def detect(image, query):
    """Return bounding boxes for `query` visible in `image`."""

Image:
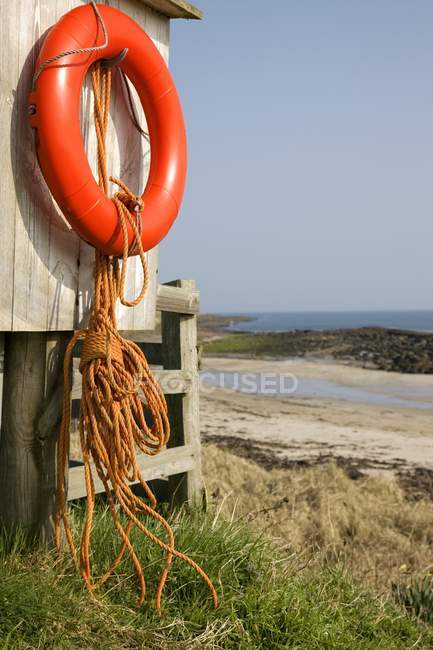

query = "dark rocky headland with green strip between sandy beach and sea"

[201,317,433,374]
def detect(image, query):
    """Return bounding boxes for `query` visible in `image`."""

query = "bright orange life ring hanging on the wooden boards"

[29,5,186,255]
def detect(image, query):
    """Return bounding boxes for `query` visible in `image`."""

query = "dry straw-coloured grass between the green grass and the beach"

[203,444,433,592]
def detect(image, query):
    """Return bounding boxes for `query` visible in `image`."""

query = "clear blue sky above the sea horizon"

[160,0,433,312]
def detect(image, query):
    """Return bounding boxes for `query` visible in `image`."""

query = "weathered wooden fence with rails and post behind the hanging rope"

[68,280,202,502]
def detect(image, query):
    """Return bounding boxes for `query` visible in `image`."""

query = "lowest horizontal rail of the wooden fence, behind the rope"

[68,447,196,500]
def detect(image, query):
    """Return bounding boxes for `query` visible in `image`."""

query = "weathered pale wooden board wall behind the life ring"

[0,0,169,331]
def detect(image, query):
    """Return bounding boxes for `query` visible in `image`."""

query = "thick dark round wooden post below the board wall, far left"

[0,332,71,544]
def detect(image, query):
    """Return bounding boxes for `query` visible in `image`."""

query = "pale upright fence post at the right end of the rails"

[161,280,203,505]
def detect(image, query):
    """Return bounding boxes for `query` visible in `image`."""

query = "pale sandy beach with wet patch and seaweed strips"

[201,356,433,474]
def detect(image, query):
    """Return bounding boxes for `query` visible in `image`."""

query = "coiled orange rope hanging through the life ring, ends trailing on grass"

[56,64,218,609]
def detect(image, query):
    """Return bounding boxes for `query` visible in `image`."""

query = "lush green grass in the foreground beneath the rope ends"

[0,506,433,650]
